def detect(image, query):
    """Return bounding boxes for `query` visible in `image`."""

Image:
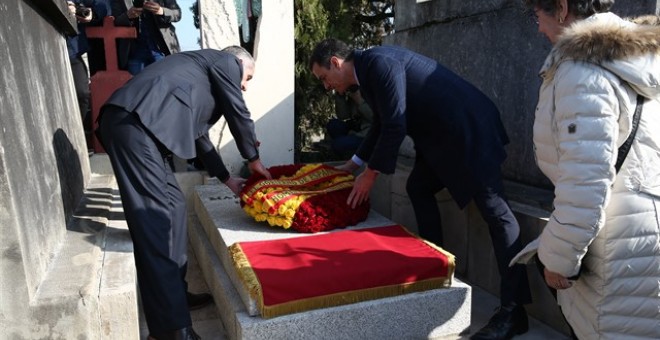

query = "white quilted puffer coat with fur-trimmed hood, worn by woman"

[514,13,660,339]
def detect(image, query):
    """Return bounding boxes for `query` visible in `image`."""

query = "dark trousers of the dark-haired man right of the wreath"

[406,156,532,306]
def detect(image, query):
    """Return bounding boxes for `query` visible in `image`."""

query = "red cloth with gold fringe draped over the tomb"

[239,225,454,306]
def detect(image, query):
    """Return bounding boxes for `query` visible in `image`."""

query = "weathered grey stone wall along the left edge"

[0,0,90,339]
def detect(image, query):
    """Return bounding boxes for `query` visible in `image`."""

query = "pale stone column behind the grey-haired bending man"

[200,0,295,175]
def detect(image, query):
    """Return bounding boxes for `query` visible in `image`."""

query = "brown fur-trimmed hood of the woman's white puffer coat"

[541,13,660,98]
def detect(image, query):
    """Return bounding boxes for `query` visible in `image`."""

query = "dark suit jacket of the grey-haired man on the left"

[104,49,259,180]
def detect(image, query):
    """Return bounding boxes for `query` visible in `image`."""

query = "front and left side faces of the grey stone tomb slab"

[189,211,472,340]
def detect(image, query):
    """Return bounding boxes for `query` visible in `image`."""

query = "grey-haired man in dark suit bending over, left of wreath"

[99,46,271,340]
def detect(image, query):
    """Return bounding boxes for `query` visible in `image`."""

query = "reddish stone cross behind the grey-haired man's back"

[85,16,137,153]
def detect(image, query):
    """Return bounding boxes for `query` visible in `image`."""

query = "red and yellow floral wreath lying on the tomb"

[241,164,370,233]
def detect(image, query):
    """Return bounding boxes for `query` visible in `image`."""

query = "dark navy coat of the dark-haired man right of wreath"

[354,46,508,207]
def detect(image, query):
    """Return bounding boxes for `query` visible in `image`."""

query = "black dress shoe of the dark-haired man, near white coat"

[470,306,529,340]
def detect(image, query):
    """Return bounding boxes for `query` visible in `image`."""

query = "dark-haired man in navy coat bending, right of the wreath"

[310,39,531,339]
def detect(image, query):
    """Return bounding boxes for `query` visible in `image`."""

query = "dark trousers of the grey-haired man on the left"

[99,106,192,334]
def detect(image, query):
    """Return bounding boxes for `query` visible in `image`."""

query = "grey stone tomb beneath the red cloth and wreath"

[189,185,471,340]
